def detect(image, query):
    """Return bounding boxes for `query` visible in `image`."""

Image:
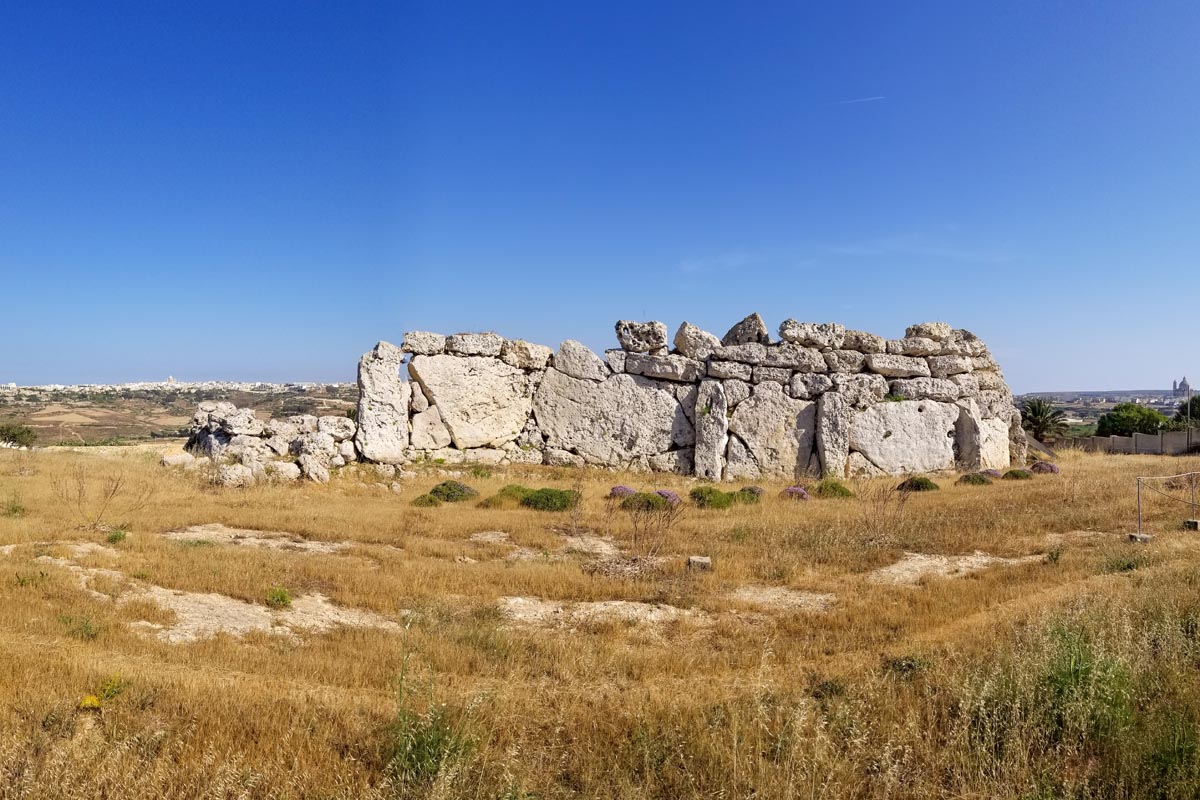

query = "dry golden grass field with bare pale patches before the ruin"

[0,447,1200,799]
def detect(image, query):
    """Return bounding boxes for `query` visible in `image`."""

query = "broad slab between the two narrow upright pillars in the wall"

[730,383,816,477]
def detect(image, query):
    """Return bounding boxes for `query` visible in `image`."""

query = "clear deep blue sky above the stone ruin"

[0,0,1200,392]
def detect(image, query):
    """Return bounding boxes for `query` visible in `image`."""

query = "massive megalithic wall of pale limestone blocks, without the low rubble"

[354,314,1025,480]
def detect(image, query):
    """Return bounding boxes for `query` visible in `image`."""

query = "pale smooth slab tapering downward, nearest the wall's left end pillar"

[408,355,530,450]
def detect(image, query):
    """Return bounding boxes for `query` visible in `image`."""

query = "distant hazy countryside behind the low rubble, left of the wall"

[0,386,358,445]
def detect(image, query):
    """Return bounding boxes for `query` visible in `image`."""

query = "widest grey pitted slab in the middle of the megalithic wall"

[533,368,696,467]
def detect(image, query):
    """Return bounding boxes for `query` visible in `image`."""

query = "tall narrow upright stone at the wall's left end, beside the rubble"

[354,342,413,464]
